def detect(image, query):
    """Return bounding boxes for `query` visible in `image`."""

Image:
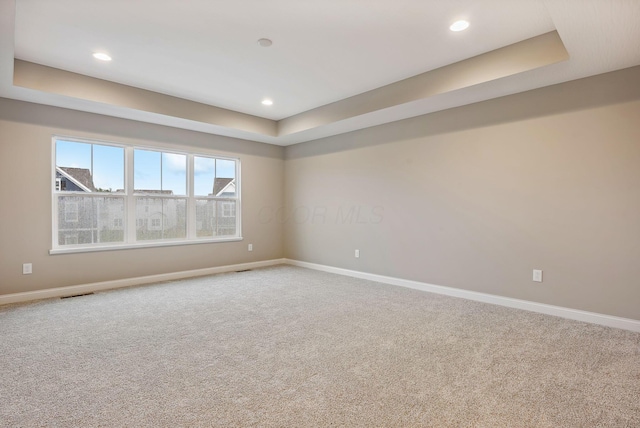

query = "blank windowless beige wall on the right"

[284,67,640,319]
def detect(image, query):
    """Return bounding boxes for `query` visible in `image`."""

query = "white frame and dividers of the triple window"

[49,135,243,254]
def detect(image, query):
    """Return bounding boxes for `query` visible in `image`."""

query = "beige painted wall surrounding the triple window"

[0,99,283,294]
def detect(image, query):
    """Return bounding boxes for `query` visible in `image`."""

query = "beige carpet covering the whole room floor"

[0,266,640,427]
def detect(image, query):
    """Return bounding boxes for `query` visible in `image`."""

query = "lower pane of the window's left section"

[58,196,124,245]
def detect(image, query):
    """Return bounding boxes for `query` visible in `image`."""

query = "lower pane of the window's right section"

[196,199,236,238]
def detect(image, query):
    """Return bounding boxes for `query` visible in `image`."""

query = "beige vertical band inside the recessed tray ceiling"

[13,31,569,144]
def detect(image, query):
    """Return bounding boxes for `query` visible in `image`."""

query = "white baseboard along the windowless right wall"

[285,259,640,332]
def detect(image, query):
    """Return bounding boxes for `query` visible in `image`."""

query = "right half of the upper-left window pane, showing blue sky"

[93,144,124,192]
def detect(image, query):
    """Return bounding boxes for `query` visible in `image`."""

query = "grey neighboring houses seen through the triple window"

[55,167,236,245]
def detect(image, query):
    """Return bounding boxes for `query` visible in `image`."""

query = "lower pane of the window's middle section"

[136,197,187,241]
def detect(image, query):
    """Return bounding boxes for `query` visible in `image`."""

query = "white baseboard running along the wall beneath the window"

[0,259,286,305]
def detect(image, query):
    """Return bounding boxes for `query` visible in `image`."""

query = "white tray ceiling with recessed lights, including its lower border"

[0,0,640,145]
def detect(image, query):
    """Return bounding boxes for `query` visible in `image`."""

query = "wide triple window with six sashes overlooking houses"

[52,137,241,252]
